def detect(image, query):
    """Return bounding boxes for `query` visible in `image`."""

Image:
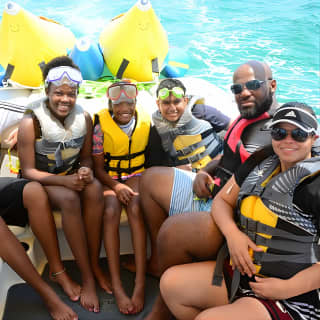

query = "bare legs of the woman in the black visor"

[160,261,271,320]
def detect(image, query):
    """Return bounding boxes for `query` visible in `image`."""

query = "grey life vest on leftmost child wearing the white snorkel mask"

[26,98,87,174]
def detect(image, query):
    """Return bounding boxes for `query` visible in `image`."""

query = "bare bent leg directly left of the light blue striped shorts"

[140,167,174,276]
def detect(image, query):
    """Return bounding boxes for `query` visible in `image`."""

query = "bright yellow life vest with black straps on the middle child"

[95,106,151,180]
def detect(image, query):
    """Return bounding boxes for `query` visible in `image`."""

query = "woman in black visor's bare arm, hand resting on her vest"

[211,176,262,277]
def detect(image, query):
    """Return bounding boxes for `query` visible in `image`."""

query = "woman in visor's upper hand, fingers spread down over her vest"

[226,230,263,277]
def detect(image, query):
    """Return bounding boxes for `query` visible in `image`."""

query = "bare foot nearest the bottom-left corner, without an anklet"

[44,293,78,320]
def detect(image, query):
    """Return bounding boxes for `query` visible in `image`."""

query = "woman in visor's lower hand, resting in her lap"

[249,276,292,300]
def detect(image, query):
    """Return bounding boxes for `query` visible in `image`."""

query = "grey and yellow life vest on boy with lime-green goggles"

[152,97,223,169]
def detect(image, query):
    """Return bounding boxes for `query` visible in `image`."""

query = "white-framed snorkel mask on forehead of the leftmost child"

[44,66,82,88]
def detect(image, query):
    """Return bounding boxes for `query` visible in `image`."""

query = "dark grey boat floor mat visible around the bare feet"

[3,258,159,320]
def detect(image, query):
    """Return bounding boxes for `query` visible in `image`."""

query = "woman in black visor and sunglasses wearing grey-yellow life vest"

[160,102,320,320]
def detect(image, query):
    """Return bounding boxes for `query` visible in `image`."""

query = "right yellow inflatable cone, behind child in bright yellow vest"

[99,0,169,81]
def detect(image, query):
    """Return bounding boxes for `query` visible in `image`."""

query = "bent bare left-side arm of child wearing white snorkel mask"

[18,115,84,191]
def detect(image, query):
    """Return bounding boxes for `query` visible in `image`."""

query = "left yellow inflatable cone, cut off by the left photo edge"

[0,2,76,88]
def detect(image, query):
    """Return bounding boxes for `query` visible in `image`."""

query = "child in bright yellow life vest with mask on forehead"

[93,81,151,314]
